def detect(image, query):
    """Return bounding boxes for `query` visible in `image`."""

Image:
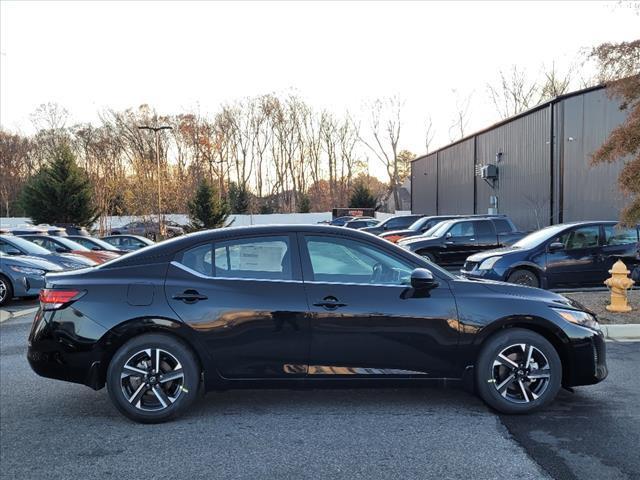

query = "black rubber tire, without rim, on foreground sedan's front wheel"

[475,328,562,414]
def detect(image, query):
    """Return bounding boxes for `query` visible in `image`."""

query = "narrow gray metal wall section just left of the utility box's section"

[438,138,475,214]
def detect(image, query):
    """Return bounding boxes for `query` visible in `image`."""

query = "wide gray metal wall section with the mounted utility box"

[475,107,551,230]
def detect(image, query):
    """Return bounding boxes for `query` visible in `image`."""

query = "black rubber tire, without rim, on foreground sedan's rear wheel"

[106,333,200,423]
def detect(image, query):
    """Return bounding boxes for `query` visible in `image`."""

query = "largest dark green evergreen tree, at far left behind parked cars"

[20,144,99,227]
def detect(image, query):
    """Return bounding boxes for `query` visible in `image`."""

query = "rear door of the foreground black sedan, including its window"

[165,235,310,378]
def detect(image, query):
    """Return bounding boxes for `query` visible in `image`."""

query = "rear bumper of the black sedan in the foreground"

[27,307,106,390]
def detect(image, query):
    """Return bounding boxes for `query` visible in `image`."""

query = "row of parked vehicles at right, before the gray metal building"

[362,215,640,289]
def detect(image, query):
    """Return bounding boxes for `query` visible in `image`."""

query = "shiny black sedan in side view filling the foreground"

[27,225,607,422]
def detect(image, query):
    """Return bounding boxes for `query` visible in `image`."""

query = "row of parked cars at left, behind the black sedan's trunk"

[0,232,154,305]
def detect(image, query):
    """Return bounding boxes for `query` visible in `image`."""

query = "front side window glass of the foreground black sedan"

[305,236,413,285]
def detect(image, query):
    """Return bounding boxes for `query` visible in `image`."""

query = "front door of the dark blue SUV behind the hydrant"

[547,225,600,287]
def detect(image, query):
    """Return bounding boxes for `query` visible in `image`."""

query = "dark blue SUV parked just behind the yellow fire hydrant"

[462,222,640,288]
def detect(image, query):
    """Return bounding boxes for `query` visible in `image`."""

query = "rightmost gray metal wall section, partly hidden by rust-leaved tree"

[557,90,627,222]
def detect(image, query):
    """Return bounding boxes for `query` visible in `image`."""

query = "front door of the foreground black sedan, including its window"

[300,234,459,378]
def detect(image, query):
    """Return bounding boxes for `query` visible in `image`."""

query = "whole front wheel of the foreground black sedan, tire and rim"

[475,328,562,414]
